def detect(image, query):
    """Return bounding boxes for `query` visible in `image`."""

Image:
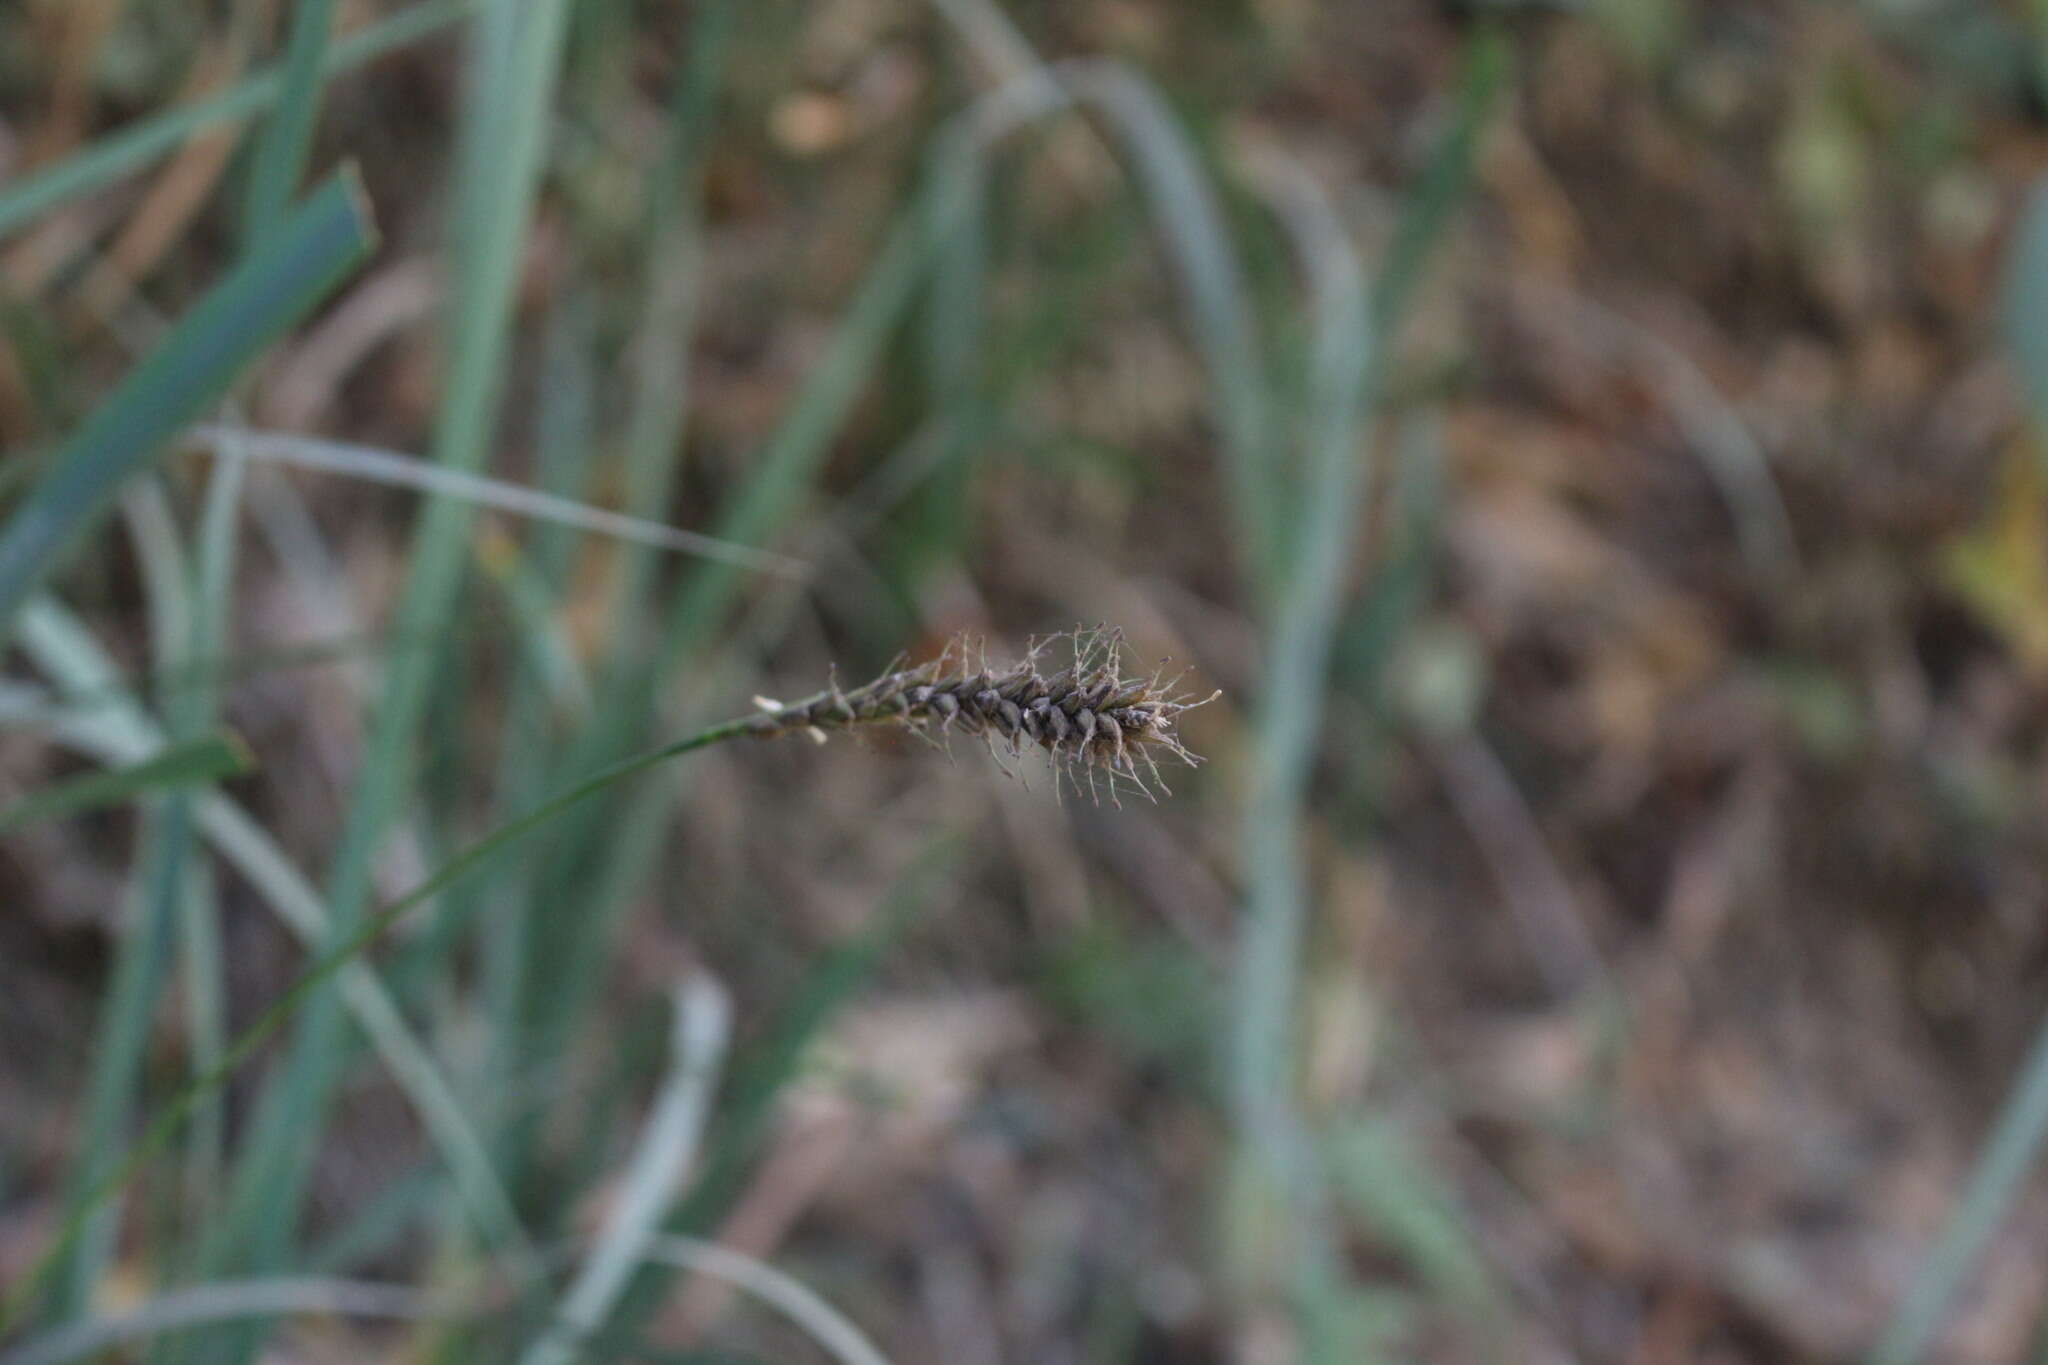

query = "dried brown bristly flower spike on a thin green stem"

[748,628,1221,800]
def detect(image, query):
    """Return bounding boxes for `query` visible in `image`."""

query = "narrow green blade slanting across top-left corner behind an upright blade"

[0,0,471,237]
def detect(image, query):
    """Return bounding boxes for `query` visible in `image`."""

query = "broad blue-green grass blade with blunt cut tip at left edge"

[0,170,375,643]
